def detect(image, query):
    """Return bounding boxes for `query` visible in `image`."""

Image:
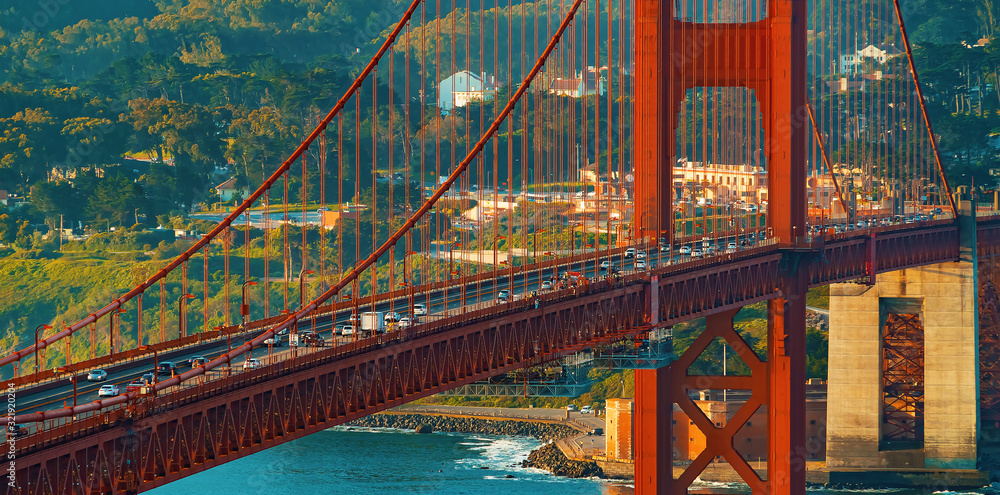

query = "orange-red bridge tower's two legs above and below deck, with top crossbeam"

[633,0,808,494]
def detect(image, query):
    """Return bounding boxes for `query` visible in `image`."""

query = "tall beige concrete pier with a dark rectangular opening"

[827,202,981,485]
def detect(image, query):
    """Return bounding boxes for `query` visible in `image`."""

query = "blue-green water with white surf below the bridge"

[147,426,1000,495]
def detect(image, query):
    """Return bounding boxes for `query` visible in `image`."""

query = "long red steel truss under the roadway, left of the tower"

[8,284,648,494]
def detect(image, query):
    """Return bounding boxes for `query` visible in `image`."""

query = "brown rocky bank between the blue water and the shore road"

[344,413,605,478]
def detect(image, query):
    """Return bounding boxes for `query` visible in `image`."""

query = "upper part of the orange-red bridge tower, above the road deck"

[633,0,808,243]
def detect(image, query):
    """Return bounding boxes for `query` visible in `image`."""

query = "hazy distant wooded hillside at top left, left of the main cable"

[0,0,406,85]
